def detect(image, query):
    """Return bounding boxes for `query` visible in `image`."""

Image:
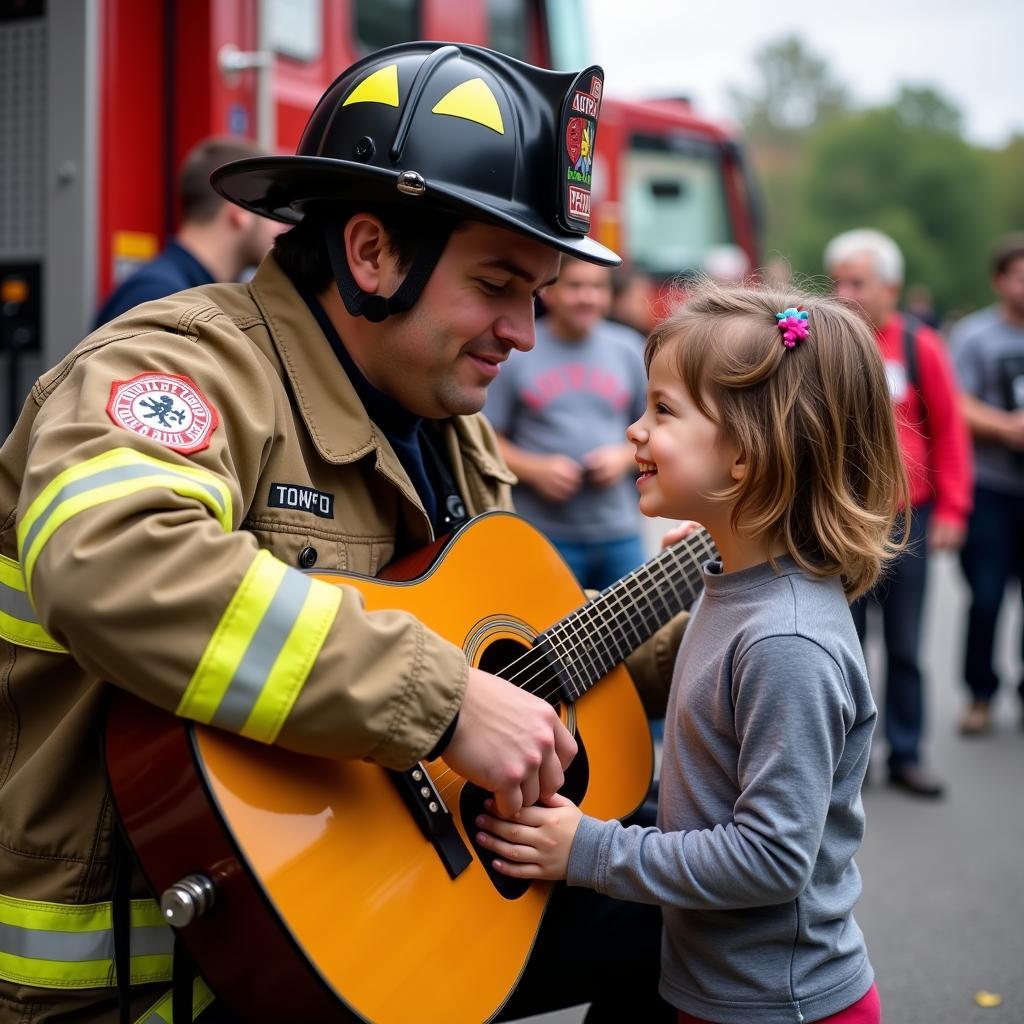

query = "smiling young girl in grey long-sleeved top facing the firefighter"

[477,285,906,1024]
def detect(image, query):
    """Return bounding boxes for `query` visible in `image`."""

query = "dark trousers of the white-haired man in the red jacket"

[850,505,932,769]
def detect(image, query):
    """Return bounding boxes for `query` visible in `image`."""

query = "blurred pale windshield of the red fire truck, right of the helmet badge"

[625,137,733,276]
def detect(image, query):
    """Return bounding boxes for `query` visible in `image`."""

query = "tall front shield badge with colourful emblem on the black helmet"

[558,68,604,234]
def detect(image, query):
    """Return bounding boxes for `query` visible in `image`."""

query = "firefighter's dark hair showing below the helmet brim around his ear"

[273,203,461,294]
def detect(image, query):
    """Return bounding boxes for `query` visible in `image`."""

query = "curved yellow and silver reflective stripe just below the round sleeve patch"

[17,449,231,593]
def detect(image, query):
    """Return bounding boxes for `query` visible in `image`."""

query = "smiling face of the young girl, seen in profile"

[627,344,742,527]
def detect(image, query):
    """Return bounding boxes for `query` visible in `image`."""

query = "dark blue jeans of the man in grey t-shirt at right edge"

[961,487,1024,700]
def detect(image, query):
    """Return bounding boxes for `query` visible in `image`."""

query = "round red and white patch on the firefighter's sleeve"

[106,373,220,455]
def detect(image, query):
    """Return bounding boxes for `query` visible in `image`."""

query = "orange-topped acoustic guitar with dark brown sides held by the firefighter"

[106,512,715,1024]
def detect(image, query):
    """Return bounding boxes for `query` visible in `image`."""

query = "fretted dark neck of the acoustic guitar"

[537,529,718,696]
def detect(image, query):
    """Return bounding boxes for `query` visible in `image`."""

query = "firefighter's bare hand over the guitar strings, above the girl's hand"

[443,669,577,817]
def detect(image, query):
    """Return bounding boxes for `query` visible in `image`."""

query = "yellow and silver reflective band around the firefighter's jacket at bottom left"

[0,894,174,988]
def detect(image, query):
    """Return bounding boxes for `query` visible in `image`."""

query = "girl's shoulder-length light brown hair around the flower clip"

[645,282,908,599]
